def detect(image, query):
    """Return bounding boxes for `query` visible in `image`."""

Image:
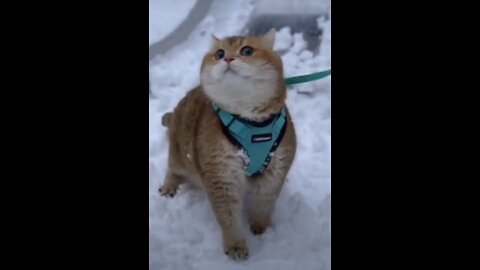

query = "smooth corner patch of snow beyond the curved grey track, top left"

[148,0,197,45]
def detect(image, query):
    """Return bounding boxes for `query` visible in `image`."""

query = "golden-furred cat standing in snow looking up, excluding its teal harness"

[159,29,296,259]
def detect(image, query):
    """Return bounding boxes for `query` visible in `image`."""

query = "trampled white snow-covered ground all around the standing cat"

[149,0,331,270]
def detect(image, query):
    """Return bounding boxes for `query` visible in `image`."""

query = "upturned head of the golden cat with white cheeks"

[201,29,286,119]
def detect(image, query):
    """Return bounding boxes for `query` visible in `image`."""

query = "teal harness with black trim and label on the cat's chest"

[214,106,287,176]
